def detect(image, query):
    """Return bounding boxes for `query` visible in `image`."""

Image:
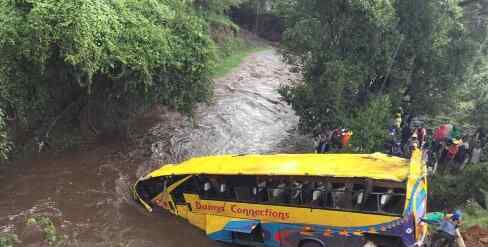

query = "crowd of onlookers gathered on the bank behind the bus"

[315,109,487,175]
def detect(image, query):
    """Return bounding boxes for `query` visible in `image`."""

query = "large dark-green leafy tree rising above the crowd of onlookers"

[277,0,474,151]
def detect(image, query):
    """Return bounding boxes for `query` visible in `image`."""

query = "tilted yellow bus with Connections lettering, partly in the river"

[133,150,427,247]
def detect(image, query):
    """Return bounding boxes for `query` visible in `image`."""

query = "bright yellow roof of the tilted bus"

[148,153,410,182]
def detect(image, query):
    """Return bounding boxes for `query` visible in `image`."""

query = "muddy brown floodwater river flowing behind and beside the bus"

[0,50,309,247]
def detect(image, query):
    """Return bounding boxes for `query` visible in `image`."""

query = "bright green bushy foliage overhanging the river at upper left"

[0,0,217,158]
